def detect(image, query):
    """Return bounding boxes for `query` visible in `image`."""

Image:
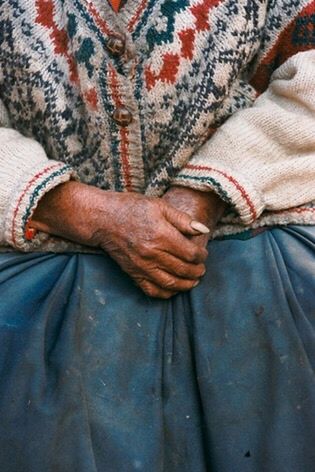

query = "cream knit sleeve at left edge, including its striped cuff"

[0,101,72,250]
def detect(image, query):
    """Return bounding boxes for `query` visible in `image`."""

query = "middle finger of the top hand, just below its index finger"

[154,252,206,279]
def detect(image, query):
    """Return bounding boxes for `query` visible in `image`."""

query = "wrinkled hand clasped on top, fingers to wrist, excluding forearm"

[92,192,207,298]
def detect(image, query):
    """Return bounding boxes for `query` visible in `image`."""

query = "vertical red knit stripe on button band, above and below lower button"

[109,66,132,192]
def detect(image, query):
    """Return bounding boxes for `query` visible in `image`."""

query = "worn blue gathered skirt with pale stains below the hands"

[0,226,315,472]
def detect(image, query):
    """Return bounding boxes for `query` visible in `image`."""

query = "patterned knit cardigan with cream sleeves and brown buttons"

[0,0,315,251]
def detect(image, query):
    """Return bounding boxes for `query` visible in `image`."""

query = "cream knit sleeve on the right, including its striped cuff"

[173,50,315,225]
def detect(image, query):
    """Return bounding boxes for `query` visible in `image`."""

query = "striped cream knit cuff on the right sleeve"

[172,159,264,225]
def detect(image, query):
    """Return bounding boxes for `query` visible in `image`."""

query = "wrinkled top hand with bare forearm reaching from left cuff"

[32,181,207,298]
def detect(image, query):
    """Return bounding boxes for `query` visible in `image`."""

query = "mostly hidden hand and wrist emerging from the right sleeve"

[163,186,226,247]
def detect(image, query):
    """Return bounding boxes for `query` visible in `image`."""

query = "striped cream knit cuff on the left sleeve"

[4,160,74,251]
